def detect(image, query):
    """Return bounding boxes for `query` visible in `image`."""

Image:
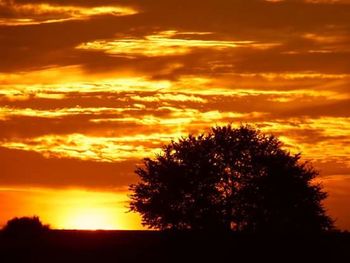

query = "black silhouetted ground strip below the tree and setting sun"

[0,230,350,263]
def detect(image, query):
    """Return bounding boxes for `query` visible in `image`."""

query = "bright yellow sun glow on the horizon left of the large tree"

[0,187,142,230]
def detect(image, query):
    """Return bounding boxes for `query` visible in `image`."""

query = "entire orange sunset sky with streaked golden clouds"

[0,0,350,230]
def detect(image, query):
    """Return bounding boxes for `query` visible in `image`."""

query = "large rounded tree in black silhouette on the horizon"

[130,125,333,233]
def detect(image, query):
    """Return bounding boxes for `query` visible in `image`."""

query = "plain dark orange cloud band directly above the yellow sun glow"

[0,147,137,188]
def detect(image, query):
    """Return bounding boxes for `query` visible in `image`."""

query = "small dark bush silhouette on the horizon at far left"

[3,216,49,236]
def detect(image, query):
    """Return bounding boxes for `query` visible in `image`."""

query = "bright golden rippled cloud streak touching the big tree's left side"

[1,134,161,162]
